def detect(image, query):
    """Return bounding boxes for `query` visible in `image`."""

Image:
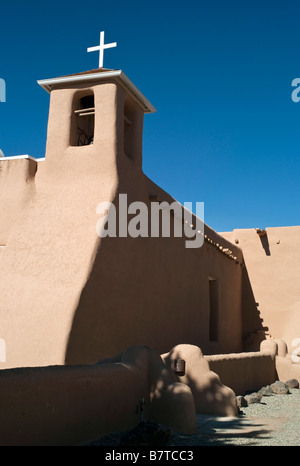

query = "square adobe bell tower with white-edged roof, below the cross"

[38,68,155,168]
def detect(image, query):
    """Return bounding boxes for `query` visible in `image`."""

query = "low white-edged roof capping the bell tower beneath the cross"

[38,68,156,113]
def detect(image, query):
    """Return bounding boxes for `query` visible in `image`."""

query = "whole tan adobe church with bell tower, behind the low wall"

[0,35,300,444]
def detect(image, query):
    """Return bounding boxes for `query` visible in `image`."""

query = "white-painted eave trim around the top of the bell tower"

[37,70,156,113]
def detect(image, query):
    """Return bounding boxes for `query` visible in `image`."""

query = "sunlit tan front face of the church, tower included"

[0,84,118,368]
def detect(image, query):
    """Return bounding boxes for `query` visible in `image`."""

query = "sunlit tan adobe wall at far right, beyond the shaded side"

[222,226,300,352]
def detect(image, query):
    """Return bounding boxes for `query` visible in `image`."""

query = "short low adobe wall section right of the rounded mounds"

[205,340,278,395]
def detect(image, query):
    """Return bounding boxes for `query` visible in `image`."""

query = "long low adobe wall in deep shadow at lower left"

[0,365,147,446]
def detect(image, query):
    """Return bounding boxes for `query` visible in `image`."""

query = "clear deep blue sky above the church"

[0,0,300,231]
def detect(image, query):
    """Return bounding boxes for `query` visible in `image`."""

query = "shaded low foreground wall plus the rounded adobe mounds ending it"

[0,345,237,446]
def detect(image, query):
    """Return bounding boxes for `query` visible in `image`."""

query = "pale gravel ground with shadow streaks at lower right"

[170,389,300,446]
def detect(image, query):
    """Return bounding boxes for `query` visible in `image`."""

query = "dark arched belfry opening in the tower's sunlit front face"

[71,93,95,146]
